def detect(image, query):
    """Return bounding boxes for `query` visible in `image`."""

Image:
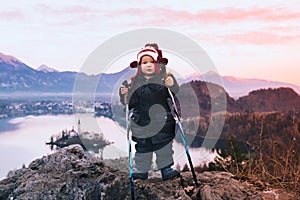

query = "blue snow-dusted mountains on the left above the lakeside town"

[0,53,118,93]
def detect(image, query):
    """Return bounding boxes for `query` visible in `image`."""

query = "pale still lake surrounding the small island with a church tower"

[0,114,217,179]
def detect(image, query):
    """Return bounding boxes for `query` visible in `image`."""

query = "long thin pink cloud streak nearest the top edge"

[115,7,300,24]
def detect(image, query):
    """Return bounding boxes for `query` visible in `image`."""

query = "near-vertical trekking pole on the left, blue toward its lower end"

[122,80,134,200]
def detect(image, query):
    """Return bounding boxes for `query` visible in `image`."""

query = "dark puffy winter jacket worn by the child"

[120,74,179,144]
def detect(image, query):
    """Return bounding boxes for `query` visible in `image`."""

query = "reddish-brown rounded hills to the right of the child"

[176,81,300,115]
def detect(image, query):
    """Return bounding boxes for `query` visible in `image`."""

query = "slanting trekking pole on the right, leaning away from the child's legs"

[168,88,199,187]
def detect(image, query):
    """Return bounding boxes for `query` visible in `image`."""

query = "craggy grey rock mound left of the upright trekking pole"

[0,146,127,199]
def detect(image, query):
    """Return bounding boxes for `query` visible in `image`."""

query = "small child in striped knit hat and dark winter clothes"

[120,44,180,180]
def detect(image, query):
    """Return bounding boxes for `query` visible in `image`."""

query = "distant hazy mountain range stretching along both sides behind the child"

[0,53,300,99]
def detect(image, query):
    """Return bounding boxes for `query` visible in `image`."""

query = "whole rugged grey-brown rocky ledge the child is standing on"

[0,146,296,200]
